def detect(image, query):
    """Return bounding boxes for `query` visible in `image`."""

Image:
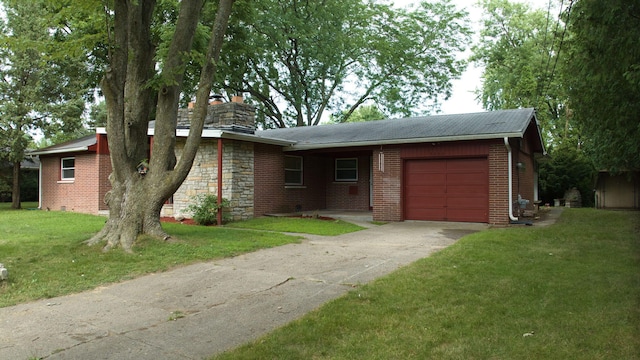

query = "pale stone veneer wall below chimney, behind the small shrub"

[162,139,254,221]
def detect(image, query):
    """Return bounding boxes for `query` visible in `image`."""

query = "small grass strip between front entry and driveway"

[226,217,364,236]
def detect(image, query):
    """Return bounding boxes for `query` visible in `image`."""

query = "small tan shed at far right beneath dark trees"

[595,170,640,209]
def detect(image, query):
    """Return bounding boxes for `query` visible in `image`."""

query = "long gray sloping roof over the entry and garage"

[256,108,542,150]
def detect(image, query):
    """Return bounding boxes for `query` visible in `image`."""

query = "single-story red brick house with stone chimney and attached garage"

[31,101,545,226]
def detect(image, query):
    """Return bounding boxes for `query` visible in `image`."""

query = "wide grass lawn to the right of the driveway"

[215,209,640,360]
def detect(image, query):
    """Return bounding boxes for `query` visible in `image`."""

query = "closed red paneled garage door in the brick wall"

[404,158,489,222]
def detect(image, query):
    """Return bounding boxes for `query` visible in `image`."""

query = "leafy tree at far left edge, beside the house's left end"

[0,0,87,209]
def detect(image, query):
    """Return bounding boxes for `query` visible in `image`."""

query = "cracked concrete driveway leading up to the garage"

[0,221,487,360]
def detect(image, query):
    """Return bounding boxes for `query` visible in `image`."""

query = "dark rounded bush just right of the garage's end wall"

[539,145,596,206]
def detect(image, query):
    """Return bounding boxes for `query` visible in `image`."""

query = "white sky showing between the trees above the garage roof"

[392,0,557,114]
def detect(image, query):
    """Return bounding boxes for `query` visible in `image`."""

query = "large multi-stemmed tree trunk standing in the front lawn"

[87,0,234,251]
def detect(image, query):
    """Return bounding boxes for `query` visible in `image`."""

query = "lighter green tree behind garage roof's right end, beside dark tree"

[472,0,579,147]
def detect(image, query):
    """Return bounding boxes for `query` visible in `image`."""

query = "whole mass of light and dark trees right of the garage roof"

[471,0,640,205]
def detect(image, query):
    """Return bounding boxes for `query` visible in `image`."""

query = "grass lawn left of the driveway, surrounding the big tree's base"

[0,208,310,307]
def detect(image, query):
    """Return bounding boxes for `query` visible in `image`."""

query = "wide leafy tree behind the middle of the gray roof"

[212,0,469,127]
